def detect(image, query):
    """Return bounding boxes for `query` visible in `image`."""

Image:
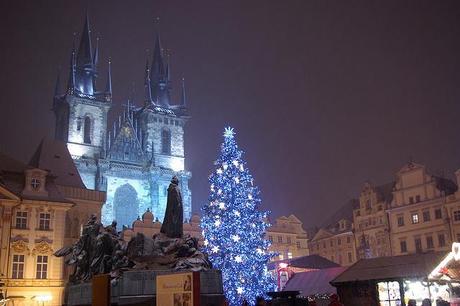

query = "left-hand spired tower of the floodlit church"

[53,15,112,189]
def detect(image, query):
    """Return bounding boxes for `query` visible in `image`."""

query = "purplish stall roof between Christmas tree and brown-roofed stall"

[283,267,346,296]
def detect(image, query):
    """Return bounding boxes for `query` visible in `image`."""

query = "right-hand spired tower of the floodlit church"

[136,34,191,219]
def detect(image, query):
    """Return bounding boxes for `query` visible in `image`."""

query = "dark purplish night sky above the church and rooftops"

[0,0,460,226]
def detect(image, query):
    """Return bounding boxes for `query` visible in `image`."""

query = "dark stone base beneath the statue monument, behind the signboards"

[64,270,224,306]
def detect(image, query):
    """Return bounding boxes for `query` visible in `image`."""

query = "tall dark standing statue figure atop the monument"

[160,176,184,238]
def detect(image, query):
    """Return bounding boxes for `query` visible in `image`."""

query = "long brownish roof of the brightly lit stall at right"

[331,252,447,285]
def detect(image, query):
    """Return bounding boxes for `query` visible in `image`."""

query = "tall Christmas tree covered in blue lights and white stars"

[201,127,276,306]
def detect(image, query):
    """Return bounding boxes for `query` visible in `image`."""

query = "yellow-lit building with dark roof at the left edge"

[0,142,105,306]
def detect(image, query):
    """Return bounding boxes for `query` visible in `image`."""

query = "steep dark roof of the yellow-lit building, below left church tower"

[29,138,86,188]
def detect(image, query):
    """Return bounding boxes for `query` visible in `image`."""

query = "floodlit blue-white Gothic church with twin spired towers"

[53,16,191,229]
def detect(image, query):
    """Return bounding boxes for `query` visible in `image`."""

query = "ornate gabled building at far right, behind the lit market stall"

[387,162,457,255]
